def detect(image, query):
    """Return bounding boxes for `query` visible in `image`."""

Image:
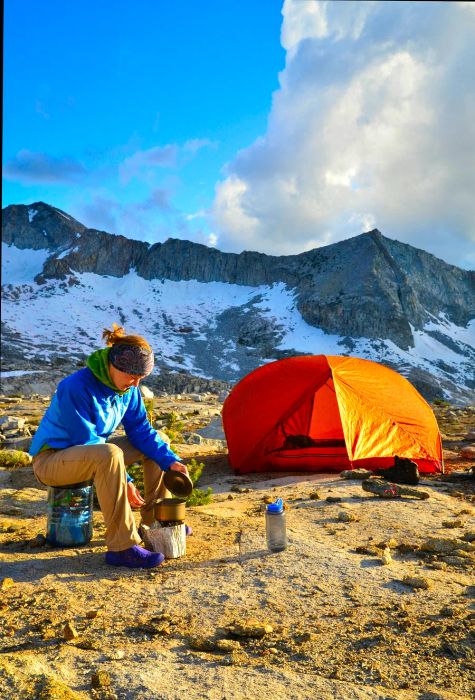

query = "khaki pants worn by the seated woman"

[33,436,171,552]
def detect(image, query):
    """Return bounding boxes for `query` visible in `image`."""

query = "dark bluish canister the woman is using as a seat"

[46,481,94,547]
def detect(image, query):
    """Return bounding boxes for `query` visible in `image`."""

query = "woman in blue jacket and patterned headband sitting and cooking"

[30,324,188,569]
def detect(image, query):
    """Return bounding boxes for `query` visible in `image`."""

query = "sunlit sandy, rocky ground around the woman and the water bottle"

[0,396,475,700]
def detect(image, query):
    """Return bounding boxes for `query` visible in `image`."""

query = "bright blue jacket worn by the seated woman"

[30,367,179,471]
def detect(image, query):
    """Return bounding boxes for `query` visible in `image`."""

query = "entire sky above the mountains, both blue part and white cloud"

[3,0,475,269]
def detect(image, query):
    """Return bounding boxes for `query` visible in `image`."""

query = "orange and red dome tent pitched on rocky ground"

[223,355,443,474]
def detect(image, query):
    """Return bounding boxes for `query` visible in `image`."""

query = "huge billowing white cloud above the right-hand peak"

[213,0,475,266]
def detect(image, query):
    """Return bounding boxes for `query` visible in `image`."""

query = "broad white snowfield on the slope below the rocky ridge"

[3,260,475,396]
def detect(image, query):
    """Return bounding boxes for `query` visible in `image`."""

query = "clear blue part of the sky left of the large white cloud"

[3,0,284,242]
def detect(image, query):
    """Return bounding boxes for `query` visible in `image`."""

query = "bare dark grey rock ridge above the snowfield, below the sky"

[2,202,475,356]
